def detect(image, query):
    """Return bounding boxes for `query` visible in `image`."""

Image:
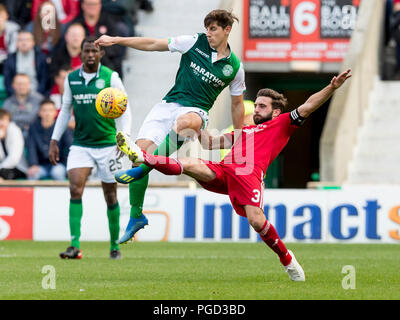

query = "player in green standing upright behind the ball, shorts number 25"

[49,37,131,259]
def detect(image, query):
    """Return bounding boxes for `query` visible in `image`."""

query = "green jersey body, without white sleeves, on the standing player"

[68,65,116,148]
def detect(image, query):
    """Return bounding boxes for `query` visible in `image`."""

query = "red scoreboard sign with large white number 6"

[243,0,360,62]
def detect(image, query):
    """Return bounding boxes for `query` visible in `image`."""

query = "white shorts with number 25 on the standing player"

[67,145,128,183]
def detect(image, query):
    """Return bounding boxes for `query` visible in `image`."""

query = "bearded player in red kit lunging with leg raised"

[117,69,351,281]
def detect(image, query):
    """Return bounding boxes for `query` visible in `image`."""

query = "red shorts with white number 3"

[197,160,264,217]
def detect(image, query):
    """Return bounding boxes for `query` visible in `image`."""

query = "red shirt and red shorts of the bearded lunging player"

[198,110,301,217]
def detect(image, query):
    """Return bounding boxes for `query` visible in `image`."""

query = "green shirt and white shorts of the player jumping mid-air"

[136,33,246,145]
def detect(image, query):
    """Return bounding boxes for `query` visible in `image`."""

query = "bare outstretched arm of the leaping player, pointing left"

[95,35,168,51]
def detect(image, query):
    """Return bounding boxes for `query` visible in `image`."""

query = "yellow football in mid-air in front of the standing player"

[96,88,128,119]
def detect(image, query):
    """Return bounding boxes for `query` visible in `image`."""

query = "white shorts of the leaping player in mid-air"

[136,101,208,146]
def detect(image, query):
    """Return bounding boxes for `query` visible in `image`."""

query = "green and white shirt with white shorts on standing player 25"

[52,65,131,183]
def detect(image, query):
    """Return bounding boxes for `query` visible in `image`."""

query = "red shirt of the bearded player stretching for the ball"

[222,113,299,175]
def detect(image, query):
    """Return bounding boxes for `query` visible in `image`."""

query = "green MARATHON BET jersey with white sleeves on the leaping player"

[164,33,245,112]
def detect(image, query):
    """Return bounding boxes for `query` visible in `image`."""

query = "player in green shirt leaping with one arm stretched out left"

[96,10,245,243]
